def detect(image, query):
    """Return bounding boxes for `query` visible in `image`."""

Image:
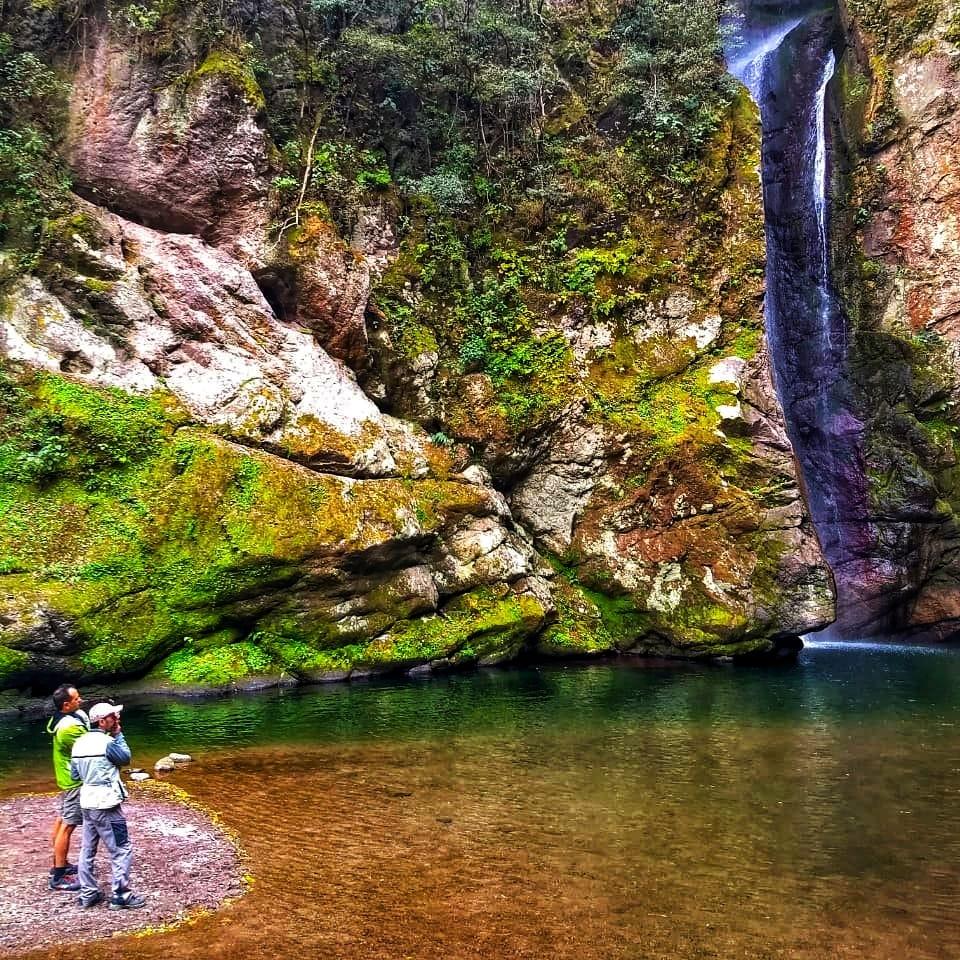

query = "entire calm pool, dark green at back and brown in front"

[0,645,960,960]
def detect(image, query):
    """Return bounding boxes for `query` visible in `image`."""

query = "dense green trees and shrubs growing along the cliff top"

[0,0,731,244]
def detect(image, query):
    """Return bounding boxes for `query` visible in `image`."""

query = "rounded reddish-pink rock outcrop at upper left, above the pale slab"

[67,28,272,262]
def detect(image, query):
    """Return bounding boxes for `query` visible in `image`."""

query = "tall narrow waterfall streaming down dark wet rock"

[725,0,875,632]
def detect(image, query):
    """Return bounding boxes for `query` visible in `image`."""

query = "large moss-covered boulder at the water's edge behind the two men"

[0,372,553,687]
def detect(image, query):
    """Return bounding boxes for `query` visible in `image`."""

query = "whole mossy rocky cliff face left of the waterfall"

[0,4,833,687]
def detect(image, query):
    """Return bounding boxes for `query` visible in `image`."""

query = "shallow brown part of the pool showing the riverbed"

[1,727,960,960]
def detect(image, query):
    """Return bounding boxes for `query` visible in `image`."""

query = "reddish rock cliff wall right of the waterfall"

[835,0,960,639]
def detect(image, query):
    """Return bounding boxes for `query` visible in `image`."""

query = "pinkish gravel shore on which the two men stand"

[0,781,244,953]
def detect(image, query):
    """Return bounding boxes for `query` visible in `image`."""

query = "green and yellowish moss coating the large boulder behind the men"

[0,364,527,682]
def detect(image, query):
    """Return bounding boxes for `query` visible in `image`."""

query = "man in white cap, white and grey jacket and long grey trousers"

[70,703,146,910]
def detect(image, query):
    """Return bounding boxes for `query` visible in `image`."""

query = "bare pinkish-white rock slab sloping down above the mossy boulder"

[0,205,398,476]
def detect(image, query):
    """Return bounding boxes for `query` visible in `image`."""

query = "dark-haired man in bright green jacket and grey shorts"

[47,684,90,893]
